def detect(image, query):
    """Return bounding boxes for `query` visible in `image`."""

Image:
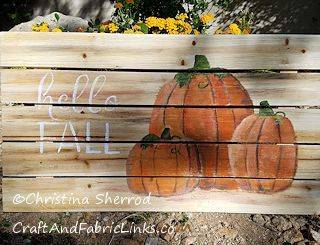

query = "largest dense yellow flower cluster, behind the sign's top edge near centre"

[145,13,193,34]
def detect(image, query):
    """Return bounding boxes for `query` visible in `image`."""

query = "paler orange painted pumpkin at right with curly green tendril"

[229,101,297,193]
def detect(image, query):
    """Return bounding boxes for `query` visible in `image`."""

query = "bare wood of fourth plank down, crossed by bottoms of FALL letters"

[2,142,320,179]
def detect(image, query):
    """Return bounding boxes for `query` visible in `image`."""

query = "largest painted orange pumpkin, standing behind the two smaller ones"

[149,55,253,189]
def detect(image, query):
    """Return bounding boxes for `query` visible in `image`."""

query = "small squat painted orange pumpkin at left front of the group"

[127,129,200,197]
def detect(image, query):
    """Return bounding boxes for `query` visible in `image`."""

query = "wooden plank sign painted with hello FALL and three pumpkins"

[0,33,320,214]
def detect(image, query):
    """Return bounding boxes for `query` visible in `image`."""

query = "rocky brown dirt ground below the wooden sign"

[0,206,320,245]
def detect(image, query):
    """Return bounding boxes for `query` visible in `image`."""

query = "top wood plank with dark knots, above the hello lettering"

[0,32,320,70]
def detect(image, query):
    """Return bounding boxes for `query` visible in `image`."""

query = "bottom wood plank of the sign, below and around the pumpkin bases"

[3,178,320,214]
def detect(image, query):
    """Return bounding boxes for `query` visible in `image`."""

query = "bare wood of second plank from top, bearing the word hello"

[1,69,320,106]
